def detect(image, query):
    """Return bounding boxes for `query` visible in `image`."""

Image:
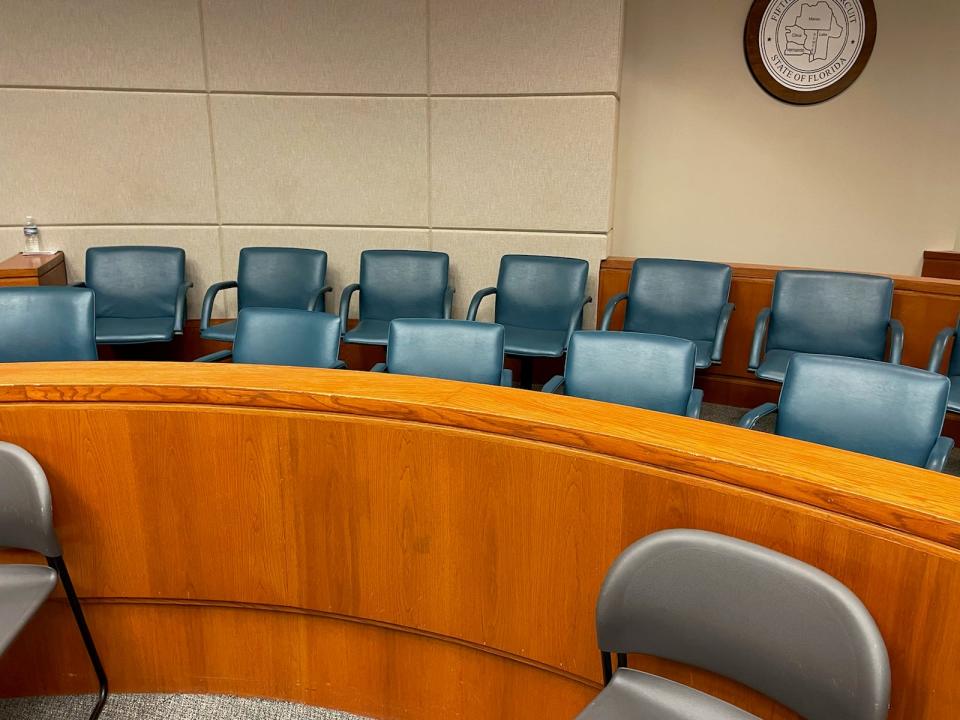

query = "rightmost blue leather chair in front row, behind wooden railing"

[739,355,953,471]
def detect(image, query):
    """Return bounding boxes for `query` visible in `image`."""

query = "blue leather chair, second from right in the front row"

[543,331,703,418]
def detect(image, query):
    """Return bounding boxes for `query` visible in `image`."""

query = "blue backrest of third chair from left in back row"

[360,250,450,320]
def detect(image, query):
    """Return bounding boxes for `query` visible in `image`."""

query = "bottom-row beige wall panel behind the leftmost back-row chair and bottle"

[0,225,222,318]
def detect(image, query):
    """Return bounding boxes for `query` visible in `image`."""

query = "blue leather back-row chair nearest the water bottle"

[79,245,193,345]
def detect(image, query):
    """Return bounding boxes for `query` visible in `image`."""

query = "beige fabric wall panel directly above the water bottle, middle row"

[0,90,216,225]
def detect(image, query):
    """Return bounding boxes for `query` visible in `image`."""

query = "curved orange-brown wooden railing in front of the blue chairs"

[0,363,960,720]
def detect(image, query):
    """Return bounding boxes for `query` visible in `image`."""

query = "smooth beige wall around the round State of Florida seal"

[611,0,960,274]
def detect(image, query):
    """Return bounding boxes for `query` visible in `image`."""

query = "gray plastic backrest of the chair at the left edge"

[0,442,61,557]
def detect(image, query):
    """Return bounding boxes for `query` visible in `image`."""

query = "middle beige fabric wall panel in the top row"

[203,0,427,95]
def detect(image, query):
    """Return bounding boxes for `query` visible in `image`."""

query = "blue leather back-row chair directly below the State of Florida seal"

[748,270,903,382]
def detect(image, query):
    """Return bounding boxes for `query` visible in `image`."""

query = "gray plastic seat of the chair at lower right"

[577,668,757,720]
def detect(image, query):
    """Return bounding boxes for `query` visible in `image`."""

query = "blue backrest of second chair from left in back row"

[237,247,327,310]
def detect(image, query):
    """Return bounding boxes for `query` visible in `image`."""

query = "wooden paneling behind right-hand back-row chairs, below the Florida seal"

[597,258,960,416]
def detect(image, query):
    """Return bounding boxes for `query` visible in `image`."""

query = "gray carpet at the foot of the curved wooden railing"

[0,694,372,720]
